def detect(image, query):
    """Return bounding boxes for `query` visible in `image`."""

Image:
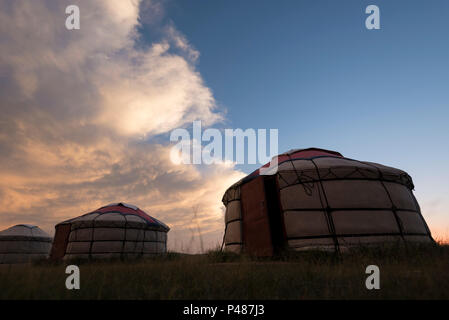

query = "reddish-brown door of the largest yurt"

[242,176,273,256]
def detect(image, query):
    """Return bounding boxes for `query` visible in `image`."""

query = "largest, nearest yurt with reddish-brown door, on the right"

[222,148,433,256]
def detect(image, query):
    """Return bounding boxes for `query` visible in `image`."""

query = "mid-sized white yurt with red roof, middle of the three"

[51,203,170,260]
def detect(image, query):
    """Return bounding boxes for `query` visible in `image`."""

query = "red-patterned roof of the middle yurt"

[58,202,170,232]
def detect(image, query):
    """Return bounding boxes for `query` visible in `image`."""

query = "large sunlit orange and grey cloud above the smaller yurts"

[0,0,242,250]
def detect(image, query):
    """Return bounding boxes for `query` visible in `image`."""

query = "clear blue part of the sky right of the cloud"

[142,0,449,235]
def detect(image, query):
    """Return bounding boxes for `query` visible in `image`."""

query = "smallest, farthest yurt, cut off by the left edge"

[0,224,52,264]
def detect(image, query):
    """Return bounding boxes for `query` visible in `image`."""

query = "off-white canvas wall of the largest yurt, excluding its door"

[223,157,432,252]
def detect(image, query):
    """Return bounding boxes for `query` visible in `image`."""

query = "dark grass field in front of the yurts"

[0,245,449,300]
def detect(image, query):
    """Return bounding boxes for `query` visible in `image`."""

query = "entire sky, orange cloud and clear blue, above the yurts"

[0,0,449,252]
